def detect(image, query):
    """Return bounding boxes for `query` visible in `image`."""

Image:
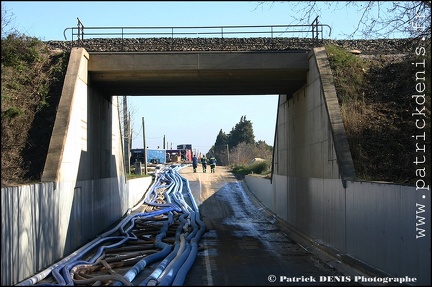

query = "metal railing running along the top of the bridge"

[63,17,331,51]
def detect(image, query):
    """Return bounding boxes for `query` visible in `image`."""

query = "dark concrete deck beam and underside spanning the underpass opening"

[88,51,308,95]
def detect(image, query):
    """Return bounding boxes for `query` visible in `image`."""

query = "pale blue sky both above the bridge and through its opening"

[1,1,412,153]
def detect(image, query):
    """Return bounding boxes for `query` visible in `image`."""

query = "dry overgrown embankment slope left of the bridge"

[1,33,68,186]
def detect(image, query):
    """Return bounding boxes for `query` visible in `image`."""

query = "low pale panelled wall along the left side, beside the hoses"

[1,177,152,286]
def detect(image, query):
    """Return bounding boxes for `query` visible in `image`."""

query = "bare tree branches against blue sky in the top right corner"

[258,1,431,39]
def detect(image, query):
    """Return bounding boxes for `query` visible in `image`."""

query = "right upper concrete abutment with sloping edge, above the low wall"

[274,48,355,186]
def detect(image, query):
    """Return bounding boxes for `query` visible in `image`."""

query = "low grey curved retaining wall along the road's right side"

[245,175,431,286]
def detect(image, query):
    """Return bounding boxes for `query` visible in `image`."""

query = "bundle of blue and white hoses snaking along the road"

[17,166,205,286]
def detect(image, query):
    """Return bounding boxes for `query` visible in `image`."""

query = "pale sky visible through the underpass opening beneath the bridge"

[123,95,278,154]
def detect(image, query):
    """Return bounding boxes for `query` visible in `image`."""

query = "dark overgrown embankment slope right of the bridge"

[326,45,431,184]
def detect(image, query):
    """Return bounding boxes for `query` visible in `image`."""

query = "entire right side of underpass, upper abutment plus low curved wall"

[245,48,431,286]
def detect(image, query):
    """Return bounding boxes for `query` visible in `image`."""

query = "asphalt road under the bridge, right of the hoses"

[180,167,362,286]
